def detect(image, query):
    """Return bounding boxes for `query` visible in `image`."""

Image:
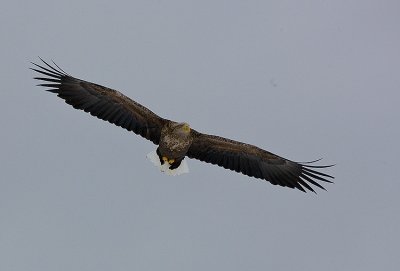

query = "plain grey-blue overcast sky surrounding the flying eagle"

[0,0,400,271]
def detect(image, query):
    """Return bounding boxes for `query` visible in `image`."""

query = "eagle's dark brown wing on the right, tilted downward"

[187,130,333,192]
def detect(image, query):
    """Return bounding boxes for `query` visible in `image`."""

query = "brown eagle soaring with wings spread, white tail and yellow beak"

[31,58,333,192]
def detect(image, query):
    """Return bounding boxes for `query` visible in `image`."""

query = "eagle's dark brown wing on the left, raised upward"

[31,59,168,144]
